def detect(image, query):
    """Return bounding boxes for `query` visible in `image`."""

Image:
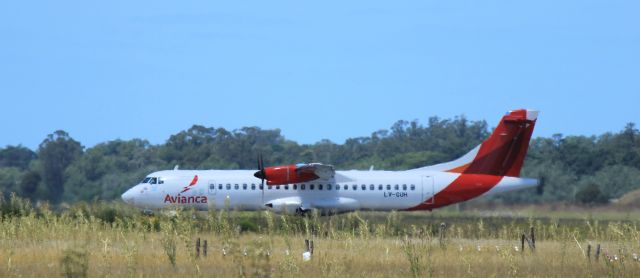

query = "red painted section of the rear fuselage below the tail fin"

[407,174,503,210]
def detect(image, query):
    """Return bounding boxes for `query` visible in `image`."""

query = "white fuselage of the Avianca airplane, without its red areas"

[122,169,537,213]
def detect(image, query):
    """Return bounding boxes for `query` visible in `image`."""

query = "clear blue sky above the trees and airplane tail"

[0,0,640,148]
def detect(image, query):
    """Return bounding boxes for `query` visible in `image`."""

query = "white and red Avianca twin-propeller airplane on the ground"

[122,109,539,215]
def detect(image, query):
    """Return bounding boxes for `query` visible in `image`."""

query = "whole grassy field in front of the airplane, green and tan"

[0,194,640,277]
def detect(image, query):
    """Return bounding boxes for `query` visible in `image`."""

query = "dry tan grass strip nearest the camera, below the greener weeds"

[0,234,640,277]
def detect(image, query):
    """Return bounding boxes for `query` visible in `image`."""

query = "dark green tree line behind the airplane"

[0,116,640,204]
